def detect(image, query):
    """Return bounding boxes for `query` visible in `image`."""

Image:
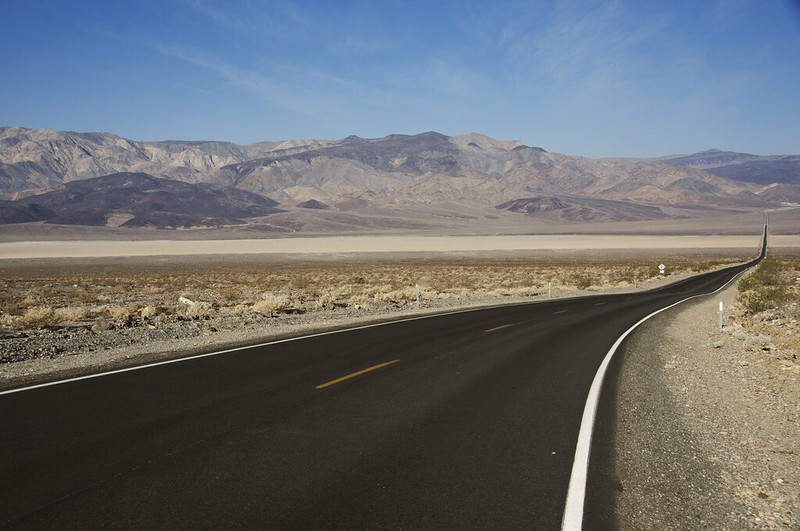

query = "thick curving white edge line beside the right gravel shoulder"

[561,270,746,531]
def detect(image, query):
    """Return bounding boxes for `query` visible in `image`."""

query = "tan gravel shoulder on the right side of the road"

[615,278,800,529]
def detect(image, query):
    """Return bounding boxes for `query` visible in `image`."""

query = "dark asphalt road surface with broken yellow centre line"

[0,248,764,529]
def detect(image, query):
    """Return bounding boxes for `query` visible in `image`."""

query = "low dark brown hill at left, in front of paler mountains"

[11,173,281,228]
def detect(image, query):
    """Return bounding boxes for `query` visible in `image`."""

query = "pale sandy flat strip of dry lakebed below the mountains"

[0,235,800,259]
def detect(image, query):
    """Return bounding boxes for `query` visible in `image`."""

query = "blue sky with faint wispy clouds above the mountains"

[0,0,800,157]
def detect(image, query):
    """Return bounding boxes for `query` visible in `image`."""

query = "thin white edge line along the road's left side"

[0,305,503,396]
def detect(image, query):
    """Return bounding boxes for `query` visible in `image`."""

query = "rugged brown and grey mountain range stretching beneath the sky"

[0,127,800,232]
